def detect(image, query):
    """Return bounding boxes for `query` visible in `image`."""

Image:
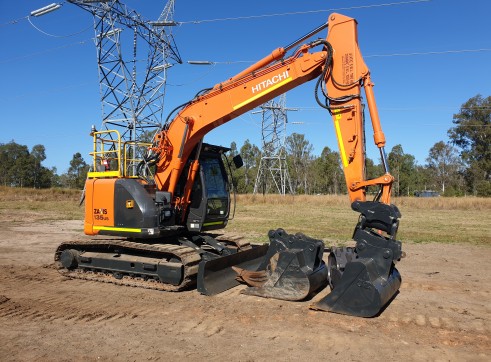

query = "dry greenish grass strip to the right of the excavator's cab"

[228,195,491,245]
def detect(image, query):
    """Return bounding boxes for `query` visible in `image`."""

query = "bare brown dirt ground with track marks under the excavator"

[0,221,491,361]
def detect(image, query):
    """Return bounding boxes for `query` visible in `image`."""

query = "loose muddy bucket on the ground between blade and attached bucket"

[234,229,327,301]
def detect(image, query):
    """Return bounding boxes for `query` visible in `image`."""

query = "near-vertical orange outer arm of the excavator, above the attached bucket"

[319,14,394,204]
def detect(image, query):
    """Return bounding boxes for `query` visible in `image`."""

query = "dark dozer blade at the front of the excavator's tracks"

[197,244,268,295]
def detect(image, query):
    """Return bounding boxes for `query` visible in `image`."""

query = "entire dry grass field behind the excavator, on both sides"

[0,187,491,246]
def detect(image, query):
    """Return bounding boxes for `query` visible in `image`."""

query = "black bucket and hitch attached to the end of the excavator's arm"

[310,202,403,317]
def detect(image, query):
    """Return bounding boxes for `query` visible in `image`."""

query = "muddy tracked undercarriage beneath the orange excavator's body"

[55,235,266,294]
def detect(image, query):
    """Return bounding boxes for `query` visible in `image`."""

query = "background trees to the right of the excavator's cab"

[231,95,491,197]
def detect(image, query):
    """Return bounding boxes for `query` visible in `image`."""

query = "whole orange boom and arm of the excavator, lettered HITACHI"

[153,14,393,215]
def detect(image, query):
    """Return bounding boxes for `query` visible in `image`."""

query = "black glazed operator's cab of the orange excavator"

[183,144,230,232]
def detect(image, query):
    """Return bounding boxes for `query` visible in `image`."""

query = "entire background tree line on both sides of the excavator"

[0,95,491,197]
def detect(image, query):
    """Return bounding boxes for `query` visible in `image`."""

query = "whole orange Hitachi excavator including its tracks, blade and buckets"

[55,14,402,317]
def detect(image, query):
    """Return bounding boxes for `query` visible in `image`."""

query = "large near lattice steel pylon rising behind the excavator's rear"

[69,0,182,173]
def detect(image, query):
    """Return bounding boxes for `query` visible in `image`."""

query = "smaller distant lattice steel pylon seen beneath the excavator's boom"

[254,94,295,195]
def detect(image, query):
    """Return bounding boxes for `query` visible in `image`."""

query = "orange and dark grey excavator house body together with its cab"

[84,145,230,238]
